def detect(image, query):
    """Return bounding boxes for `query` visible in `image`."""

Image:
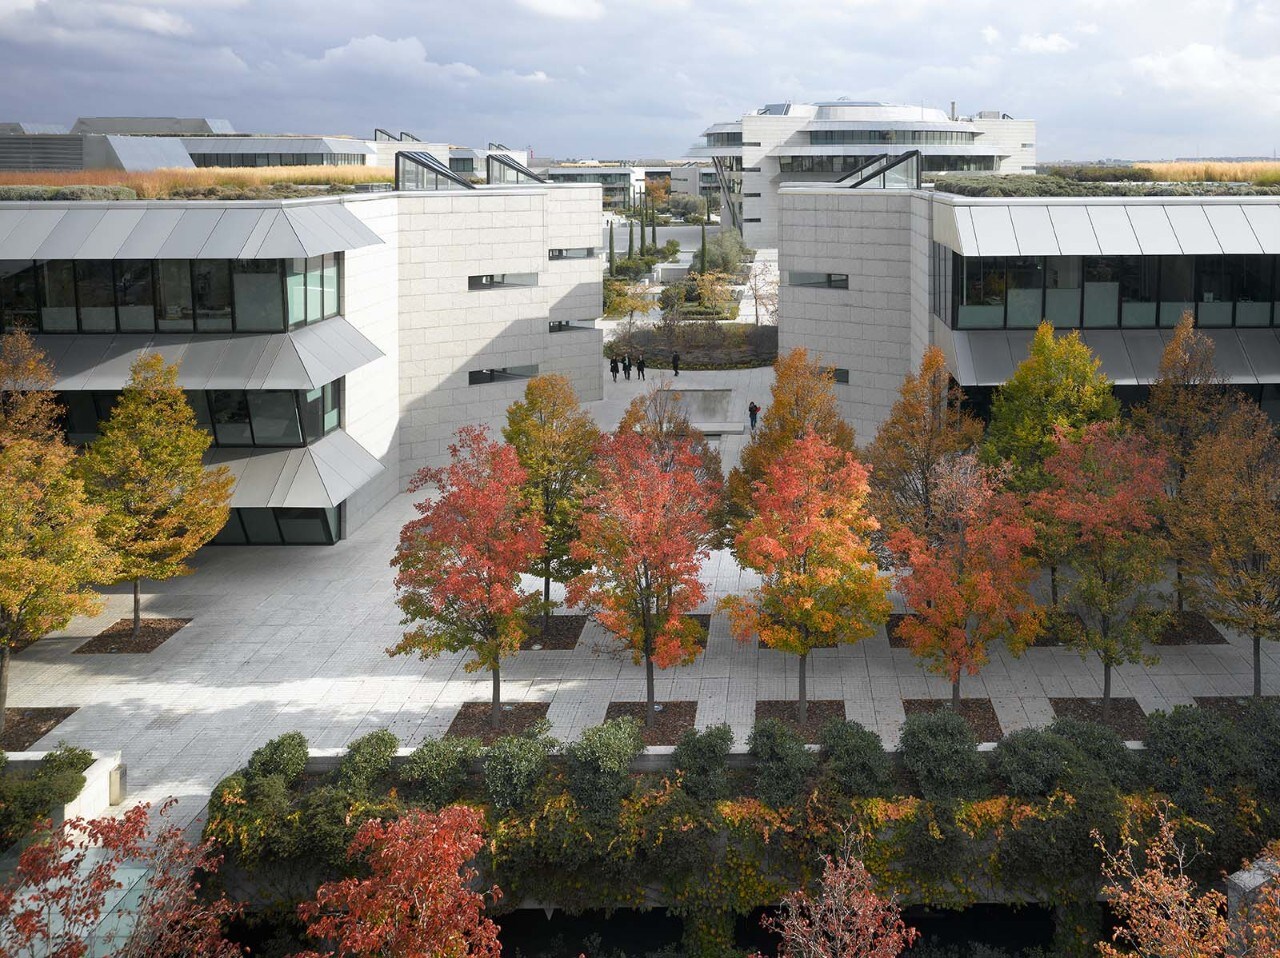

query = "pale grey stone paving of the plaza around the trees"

[10,370,1280,817]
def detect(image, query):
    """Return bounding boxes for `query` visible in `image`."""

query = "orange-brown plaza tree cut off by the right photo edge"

[1171,401,1280,697]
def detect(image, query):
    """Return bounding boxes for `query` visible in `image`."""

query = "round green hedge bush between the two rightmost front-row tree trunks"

[1144,706,1249,813]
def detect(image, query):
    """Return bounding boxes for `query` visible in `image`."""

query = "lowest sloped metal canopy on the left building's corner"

[205,429,385,508]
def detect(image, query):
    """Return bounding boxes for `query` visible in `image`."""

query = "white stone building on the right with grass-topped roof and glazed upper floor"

[778,165,1280,441]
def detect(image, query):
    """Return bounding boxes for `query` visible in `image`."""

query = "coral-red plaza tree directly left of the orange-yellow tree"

[566,432,719,724]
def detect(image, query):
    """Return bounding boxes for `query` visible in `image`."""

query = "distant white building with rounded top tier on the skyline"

[690,100,1036,248]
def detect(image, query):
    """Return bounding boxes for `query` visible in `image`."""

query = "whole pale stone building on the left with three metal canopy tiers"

[0,174,603,543]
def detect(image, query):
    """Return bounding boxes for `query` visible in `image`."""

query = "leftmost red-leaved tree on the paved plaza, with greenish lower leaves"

[388,426,543,729]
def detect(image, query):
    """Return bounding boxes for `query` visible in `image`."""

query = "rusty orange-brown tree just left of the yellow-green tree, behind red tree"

[864,346,982,542]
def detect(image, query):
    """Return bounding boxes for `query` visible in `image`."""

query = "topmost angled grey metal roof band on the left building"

[0,201,383,260]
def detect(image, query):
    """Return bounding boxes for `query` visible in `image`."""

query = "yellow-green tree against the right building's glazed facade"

[983,323,1120,492]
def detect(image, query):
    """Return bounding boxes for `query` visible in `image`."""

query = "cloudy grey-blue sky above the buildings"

[0,0,1280,160]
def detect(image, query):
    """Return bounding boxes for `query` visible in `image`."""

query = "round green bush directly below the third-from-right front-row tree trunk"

[901,708,987,802]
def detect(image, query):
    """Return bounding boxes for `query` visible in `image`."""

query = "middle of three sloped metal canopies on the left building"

[35,316,383,391]
